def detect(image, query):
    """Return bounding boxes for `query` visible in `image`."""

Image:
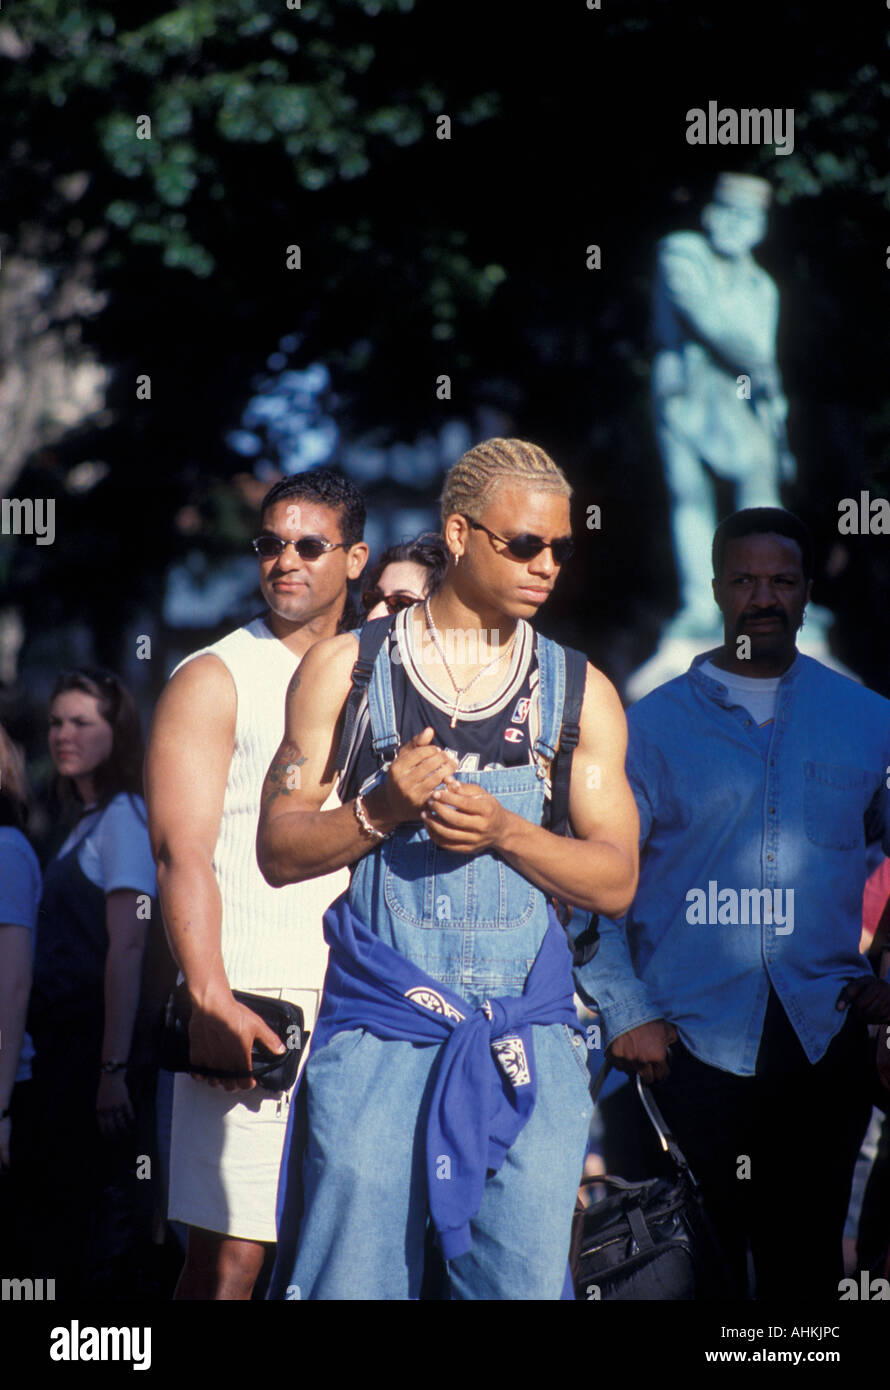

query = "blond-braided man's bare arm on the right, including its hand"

[424,666,640,916]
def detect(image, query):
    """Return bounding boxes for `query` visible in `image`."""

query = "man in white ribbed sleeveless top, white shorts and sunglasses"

[146,468,367,1300]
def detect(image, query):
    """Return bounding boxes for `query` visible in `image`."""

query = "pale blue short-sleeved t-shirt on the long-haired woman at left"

[57,792,157,897]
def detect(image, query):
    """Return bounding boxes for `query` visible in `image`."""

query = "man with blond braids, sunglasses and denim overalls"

[257,439,638,1300]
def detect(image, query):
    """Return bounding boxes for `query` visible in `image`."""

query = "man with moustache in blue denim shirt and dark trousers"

[587,507,890,1297]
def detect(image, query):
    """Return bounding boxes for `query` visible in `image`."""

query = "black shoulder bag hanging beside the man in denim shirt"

[570,1069,733,1302]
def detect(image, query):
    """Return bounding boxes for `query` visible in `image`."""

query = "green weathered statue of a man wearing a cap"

[652,174,794,637]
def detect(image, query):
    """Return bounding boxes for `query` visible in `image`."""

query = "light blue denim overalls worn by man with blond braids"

[288,637,591,1300]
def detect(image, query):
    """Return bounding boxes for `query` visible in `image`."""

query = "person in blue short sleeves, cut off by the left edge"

[0,724,40,1277]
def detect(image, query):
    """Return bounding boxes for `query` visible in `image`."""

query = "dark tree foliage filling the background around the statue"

[0,0,890,689]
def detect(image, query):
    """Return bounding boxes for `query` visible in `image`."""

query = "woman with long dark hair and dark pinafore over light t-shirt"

[29,667,157,1297]
